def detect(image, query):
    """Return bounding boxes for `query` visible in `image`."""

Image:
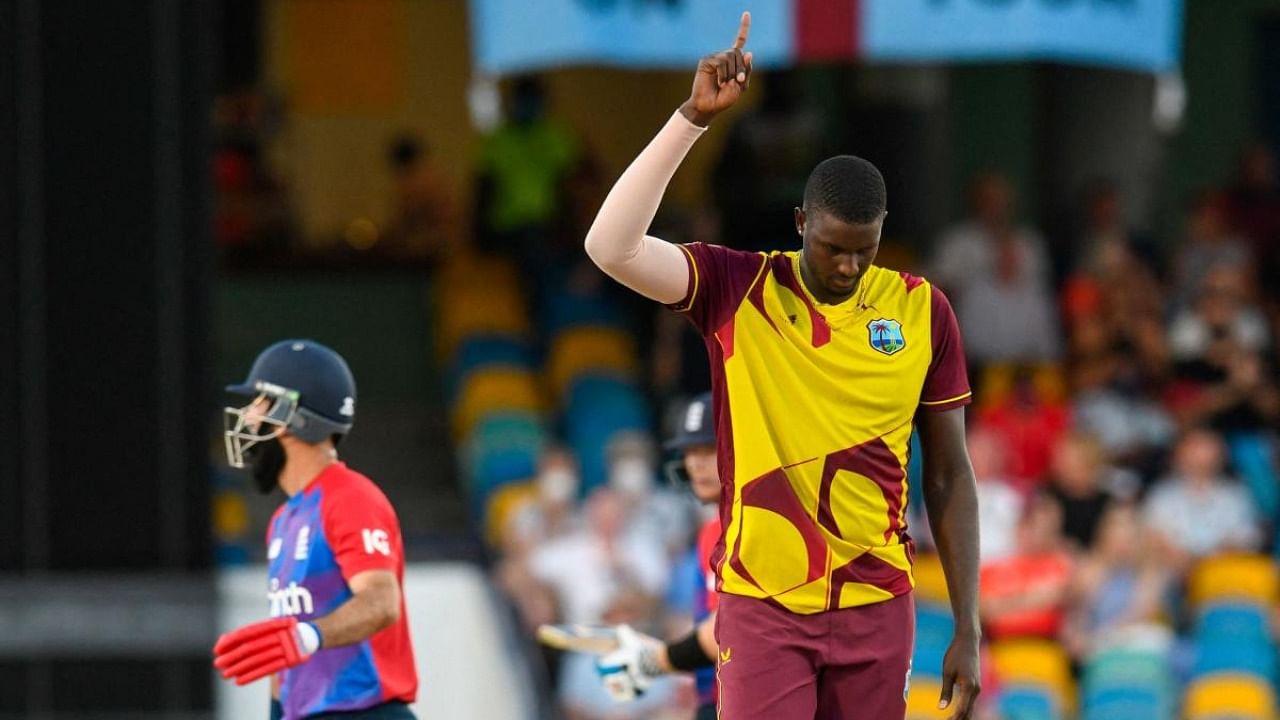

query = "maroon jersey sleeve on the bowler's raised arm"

[668,242,768,336]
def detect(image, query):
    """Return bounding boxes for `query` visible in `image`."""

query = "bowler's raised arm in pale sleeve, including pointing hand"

[585,13,751,305]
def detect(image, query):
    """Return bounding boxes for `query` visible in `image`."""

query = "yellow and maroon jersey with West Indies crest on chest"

[672,243,970,614]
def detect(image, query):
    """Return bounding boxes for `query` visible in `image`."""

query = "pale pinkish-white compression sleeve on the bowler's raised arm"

[586,111,707,305]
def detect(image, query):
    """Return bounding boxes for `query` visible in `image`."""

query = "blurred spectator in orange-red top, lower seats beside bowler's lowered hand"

[979,495,1071,639]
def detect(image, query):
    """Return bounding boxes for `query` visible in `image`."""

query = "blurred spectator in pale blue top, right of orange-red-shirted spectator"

[1062,502,1169,661]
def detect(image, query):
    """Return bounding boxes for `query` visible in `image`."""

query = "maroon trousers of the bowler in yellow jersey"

[716,593,915,720]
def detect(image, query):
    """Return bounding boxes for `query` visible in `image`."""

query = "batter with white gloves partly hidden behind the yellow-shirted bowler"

[596,392,721,720]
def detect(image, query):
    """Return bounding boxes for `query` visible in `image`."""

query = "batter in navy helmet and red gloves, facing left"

[214,340,417,720]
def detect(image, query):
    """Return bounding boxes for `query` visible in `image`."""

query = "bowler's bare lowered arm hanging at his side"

[916,407,982,720]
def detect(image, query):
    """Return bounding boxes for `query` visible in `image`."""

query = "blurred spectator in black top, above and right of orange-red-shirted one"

[1048,432,1138,552]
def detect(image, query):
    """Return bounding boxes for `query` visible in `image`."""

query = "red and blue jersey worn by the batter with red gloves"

[266,462,417,720]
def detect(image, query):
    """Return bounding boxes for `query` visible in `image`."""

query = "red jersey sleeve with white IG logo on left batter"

[323,479,404,580]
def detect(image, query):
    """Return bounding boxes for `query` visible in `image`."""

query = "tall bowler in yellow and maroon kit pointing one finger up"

[586,13,980,720]
